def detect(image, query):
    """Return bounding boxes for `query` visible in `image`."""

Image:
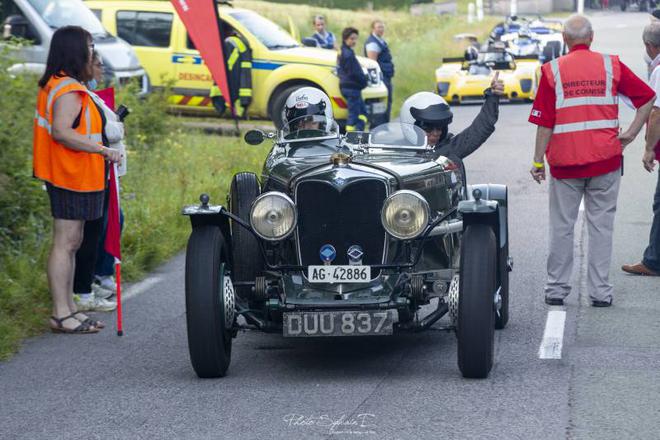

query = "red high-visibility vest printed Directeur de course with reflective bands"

[542,50,622,167]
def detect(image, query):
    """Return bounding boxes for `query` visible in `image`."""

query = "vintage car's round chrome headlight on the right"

[380,190,429,240]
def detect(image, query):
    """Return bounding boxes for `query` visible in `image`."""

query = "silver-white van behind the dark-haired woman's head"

[0,0,149,93]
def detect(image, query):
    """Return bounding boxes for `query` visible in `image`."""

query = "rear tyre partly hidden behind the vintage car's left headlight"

[229,173,264,299]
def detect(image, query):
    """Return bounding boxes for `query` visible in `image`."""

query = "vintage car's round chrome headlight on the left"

[250,191,296,241]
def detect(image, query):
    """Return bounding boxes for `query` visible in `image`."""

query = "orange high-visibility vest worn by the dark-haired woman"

[32,75,105,192]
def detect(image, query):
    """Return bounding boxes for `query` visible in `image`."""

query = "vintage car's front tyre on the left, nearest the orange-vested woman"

[186,225,235,378]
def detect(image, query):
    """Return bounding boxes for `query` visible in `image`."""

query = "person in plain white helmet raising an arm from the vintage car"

[401,72,504,177]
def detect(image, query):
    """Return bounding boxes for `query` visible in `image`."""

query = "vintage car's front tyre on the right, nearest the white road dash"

[456,224,497,379]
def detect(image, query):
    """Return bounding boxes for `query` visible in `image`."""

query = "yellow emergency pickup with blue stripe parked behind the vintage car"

[85,0,387,124]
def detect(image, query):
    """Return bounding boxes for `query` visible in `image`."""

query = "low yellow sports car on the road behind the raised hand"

[435,50,540,104]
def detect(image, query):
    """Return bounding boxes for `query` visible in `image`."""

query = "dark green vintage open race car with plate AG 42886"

[183,117,512,378]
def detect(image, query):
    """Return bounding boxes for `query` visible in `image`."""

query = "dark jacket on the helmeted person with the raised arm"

[434,89,500,184]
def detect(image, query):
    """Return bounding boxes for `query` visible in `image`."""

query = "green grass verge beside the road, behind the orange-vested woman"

[0,126,268,359]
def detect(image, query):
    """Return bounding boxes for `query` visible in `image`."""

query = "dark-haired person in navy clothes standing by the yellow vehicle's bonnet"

[337,27,368,131]
